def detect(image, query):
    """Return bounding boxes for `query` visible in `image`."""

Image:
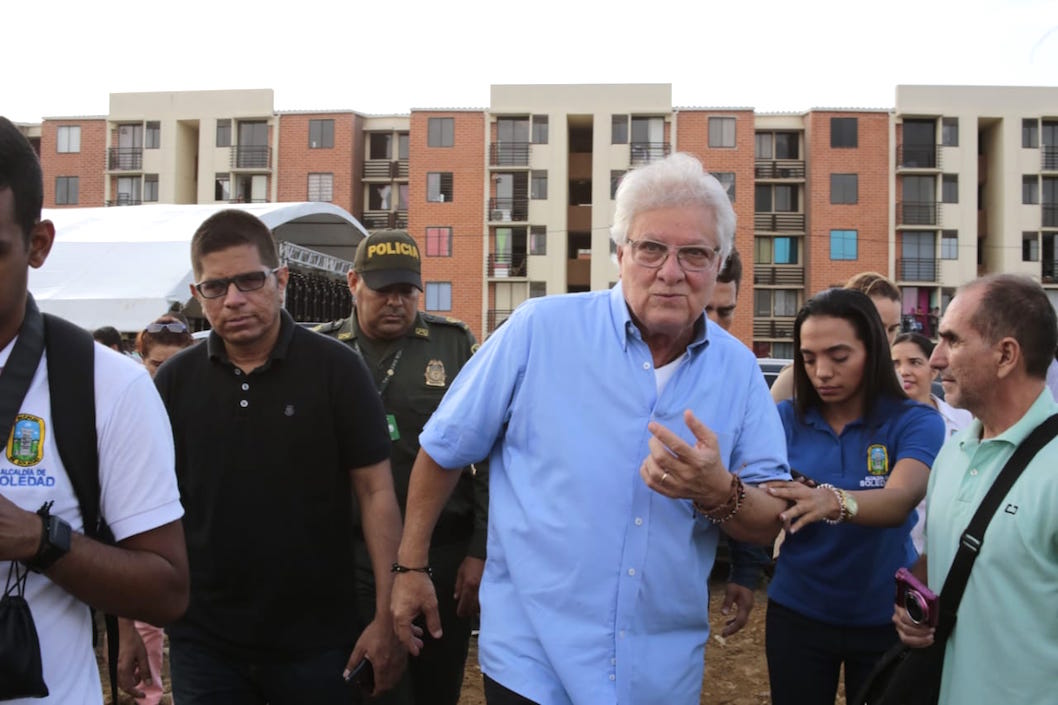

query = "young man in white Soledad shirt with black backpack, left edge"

[0,118,188,705]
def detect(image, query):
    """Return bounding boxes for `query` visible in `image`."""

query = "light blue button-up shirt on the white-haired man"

[420,284,788,705]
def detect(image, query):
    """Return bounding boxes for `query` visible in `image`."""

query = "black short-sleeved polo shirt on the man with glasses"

[154,311,390,658]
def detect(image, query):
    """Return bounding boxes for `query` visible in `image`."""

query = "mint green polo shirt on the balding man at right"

[926,388,1058,705]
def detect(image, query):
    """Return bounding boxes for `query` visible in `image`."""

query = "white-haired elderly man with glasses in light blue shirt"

[393,153,788,705]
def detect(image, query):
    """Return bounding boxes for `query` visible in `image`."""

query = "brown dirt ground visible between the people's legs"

[103,582,845,705]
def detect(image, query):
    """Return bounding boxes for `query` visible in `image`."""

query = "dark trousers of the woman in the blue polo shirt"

[765,600,898,705]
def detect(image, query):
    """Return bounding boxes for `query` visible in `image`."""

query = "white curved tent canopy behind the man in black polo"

[30,202,367,331]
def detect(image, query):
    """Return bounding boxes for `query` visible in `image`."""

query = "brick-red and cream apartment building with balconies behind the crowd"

[30,84,1058,345]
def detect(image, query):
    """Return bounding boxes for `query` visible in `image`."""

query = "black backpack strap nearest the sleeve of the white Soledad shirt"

[43,313,120,703]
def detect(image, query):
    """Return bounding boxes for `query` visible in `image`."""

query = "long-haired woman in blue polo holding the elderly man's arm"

[766,289,944,705]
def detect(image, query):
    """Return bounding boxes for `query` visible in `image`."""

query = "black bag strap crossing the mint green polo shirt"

[935,414,1058,644]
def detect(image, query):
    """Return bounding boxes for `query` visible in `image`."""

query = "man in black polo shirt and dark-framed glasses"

[156,210,404,705]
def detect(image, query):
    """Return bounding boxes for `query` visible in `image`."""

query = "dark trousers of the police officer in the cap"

[355,535,471,705]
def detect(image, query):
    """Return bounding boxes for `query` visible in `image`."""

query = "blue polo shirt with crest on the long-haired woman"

[768,398,945,627]
